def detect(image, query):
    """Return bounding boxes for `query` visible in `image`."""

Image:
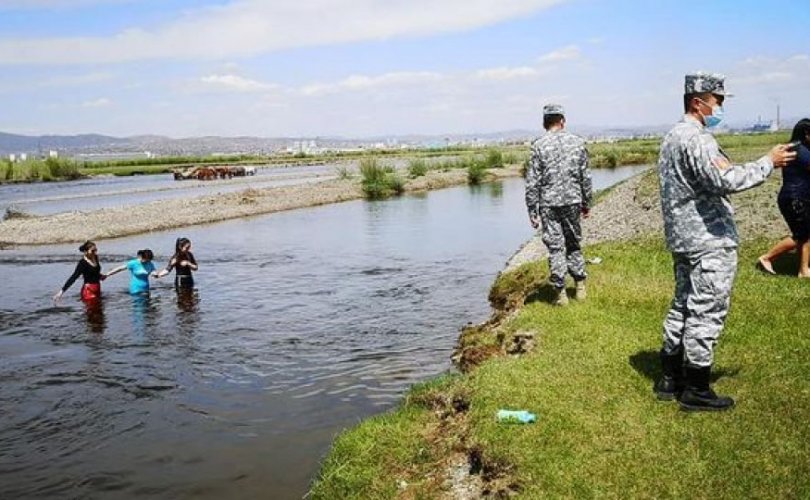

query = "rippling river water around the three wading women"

[0,167,640,499]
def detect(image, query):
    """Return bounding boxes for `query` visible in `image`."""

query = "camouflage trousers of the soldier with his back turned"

[540,204,587,288]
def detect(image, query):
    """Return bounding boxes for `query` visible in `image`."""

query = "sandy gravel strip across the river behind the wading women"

[0,167,520,246]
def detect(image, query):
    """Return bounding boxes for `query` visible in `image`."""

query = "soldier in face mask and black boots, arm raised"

[654,73,795,411]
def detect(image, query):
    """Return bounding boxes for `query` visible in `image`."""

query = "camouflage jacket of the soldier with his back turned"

[526,130,593,217]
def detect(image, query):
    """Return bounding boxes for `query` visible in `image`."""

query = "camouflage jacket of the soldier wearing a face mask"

[658,115,773,252]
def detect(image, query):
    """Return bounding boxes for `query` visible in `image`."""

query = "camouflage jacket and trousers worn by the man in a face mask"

[658,115,773,367]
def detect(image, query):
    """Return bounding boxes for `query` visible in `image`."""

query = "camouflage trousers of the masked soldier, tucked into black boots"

[663,248,737,367]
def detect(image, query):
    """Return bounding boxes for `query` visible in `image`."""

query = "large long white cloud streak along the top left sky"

[0,0,567,64]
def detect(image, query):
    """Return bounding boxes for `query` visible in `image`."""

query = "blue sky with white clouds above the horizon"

[0,0,810,138]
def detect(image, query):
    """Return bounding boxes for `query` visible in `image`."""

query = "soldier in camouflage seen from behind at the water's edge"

[526,104,593,305]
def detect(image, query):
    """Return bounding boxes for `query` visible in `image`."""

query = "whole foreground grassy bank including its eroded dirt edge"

[313,238,810,498]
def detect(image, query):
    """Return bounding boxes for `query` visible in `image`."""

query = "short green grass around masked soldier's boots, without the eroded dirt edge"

[469,240,810,498]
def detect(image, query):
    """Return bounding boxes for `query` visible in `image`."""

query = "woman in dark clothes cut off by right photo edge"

[759,118,810,278]
